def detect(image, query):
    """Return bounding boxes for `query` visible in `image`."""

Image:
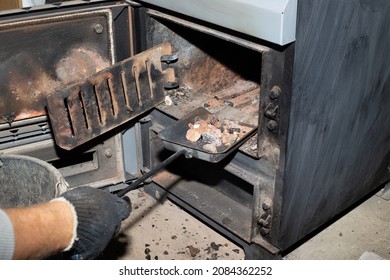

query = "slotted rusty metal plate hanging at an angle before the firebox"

[47,43,172,150]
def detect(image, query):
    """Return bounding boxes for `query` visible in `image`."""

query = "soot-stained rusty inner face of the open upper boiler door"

[0,10,114,124]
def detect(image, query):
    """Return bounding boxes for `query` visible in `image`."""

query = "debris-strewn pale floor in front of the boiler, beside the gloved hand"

[100,188,244,260]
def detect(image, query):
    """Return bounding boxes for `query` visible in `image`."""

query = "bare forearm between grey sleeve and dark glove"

[5,201,74,259]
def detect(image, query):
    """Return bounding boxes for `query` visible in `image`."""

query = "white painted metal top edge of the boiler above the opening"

[139,0,298,45]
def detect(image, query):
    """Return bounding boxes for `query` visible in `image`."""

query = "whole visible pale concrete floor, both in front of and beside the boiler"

[101,186,390,260]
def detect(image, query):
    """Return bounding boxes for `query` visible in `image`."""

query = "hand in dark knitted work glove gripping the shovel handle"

[61,187,131,259]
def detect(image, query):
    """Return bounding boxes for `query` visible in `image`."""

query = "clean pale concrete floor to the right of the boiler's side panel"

[285,191,390,260]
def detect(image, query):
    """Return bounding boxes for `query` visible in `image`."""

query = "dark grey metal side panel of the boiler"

[279,0,390,248]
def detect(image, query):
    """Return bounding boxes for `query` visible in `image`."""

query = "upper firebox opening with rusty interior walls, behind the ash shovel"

[146,14,262,137]
